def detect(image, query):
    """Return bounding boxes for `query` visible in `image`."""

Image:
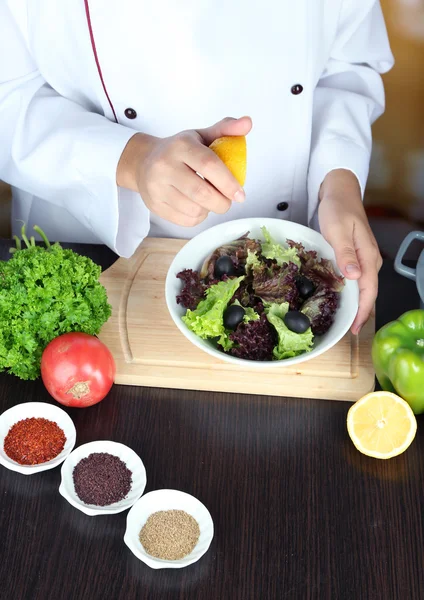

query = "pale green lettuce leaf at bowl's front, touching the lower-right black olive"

[265,302,314,360]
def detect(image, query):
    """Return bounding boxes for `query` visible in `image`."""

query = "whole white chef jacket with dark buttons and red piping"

[0,0,393,257]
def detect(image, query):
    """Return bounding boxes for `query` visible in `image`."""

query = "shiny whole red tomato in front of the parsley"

[41,333,116,408]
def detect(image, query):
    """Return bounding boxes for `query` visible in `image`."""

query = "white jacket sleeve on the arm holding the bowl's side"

[308,0,394,223]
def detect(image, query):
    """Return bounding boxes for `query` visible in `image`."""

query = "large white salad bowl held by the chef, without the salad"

[165,218,359,369]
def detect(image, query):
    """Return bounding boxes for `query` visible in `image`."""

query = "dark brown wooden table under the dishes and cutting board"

[0,242,424,600]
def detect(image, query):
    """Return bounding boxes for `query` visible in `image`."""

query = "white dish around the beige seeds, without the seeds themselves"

[124,490,214,569]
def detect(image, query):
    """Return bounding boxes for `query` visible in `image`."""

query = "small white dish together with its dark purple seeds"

[59,440,147,516]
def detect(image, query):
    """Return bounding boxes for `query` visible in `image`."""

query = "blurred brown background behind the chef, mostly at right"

[0,0,424,258]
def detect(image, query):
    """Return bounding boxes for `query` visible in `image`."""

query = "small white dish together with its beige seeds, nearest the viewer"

[124,489,214,569]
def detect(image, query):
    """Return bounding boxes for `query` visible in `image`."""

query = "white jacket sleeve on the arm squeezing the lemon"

[0,2,149,257]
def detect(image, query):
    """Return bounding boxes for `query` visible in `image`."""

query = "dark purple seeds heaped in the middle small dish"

[72,452,132,506]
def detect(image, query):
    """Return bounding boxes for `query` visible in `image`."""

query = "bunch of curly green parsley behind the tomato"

[0,226,111,379]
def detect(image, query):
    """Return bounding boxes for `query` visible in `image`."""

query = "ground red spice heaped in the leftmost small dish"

[4,417,66,465]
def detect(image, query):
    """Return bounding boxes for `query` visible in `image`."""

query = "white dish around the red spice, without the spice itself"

[0,402,77,475]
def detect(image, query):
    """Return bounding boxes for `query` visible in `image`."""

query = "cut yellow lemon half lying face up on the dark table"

[347,392,417,459]
